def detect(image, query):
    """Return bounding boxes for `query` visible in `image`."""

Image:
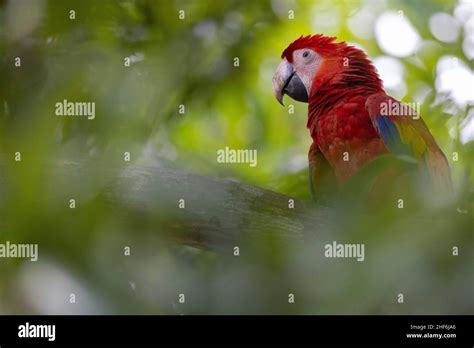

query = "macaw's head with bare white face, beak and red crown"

[273,34,381,105]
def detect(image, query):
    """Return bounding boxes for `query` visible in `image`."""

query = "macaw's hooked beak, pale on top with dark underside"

[273,58,308,106]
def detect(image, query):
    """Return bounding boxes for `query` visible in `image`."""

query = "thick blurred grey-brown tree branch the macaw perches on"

[52,162,328,249]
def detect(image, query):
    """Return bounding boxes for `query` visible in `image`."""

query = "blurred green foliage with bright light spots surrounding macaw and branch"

[0,0,474,314]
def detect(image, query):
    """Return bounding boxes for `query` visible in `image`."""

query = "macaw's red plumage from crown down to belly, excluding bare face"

[282,34,449,198]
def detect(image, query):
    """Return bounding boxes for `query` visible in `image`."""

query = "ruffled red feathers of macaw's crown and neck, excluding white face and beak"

[282,34,383,136]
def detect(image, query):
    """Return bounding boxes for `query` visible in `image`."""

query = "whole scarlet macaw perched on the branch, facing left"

[273,34,450,198]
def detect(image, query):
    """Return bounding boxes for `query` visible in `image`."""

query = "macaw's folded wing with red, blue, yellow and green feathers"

[365,93,451,187]
